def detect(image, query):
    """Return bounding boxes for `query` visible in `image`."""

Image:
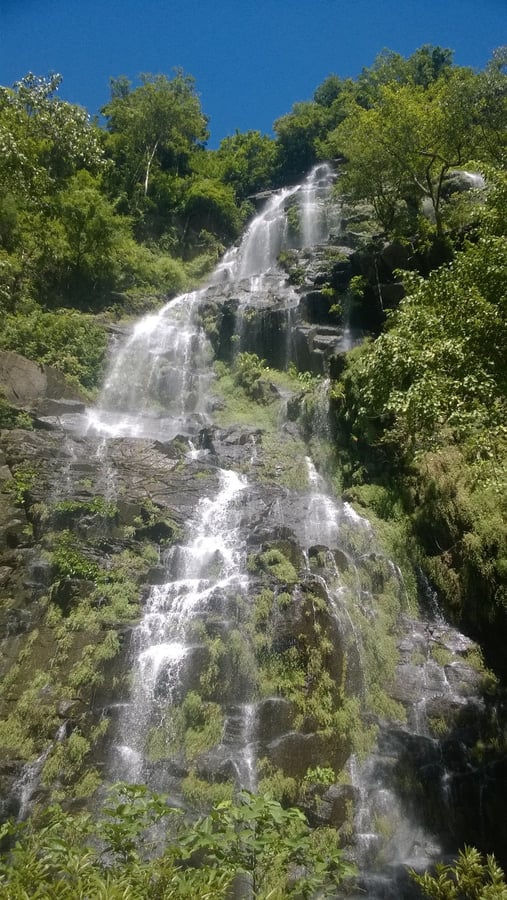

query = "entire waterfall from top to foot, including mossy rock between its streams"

[9,166,492,900]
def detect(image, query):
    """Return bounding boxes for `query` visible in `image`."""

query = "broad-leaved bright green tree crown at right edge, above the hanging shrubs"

[338,224,507,454]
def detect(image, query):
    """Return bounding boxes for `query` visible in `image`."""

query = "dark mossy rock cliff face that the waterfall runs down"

[0,172,504,897]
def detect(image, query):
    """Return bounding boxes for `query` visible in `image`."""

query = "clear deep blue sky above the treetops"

[0,0,507,146]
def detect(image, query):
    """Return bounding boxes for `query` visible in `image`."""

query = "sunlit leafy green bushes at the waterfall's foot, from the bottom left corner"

[0,785,353,900]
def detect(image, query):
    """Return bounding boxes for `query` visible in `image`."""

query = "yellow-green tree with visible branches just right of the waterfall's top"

[327,69,482,235]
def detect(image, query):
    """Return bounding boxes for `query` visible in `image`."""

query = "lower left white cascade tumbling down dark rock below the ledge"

[113,470,249,781]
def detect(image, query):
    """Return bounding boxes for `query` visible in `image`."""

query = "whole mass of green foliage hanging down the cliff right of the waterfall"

[333,167,507,641]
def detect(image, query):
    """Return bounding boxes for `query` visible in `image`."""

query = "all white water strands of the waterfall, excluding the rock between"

[75,166,488,898]
